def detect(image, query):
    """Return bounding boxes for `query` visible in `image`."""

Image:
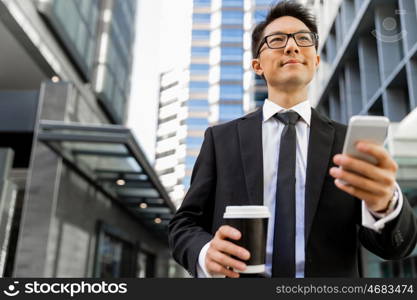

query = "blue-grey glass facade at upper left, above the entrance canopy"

[39,0,137,123]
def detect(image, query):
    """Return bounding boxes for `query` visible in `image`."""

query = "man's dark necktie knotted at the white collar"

[272,111,300,277]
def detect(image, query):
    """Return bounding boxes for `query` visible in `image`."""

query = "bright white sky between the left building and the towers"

[126,0,192,163]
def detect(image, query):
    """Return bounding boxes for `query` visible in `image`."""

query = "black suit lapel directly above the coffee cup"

[238,107,264,205]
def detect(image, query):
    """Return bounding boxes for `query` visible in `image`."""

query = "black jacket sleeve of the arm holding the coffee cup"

[168,127,216,277]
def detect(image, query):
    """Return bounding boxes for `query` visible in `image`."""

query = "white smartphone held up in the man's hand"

[343,116,389,164]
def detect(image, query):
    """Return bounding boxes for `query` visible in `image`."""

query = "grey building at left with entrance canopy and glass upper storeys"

[0,0,178,277]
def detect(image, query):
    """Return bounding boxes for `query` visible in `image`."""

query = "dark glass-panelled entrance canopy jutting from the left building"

[38,120,175,237]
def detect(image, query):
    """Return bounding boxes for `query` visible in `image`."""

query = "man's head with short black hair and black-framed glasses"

[252,1,320,88]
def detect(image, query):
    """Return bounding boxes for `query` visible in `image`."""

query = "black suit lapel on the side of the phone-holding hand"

[304,109,334,245]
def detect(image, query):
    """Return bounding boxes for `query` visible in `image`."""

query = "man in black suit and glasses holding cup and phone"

[169,1,417,277]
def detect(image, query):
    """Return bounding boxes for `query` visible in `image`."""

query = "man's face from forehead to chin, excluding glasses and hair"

[252,16,320,88]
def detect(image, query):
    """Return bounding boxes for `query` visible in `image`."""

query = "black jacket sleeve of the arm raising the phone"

[359,195,417,260]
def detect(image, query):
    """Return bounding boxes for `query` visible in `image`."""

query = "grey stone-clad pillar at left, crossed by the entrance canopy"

[13,82,75,277]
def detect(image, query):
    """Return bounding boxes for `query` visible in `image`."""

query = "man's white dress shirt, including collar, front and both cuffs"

[197,99,403,277]
